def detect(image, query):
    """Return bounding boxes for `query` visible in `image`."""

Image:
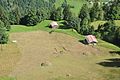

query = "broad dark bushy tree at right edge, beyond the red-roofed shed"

[98,21,119,44]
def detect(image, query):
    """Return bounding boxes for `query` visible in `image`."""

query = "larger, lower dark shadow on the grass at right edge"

[97,58,120,68]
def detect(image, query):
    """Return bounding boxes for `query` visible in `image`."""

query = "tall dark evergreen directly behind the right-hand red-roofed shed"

[79,4,94,35]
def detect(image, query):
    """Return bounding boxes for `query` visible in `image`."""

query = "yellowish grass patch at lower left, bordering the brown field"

[0,42,21,80]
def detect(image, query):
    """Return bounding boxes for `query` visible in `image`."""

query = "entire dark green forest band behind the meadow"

[0,0,120,45]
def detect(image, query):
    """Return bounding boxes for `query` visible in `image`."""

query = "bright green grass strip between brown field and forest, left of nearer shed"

[10,20,84,39]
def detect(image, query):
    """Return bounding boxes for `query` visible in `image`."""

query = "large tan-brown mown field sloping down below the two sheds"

[9,31,120,80]
